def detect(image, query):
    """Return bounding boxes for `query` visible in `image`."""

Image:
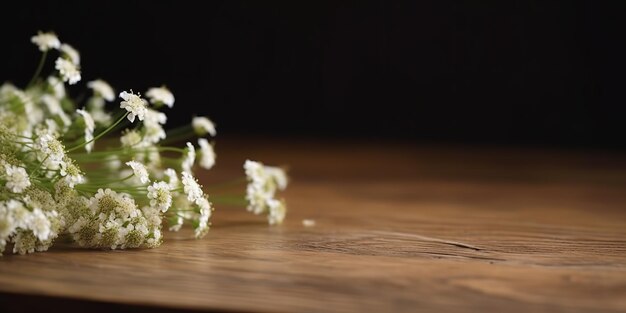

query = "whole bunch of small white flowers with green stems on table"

[0,32,287,255]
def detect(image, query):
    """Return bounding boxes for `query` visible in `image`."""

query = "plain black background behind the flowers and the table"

[0,0,626,149]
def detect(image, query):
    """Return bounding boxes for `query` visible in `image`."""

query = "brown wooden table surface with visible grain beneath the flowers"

[0,139,626,312]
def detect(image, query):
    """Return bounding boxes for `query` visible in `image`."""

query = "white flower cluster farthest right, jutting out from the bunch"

[243,160,288,225]
